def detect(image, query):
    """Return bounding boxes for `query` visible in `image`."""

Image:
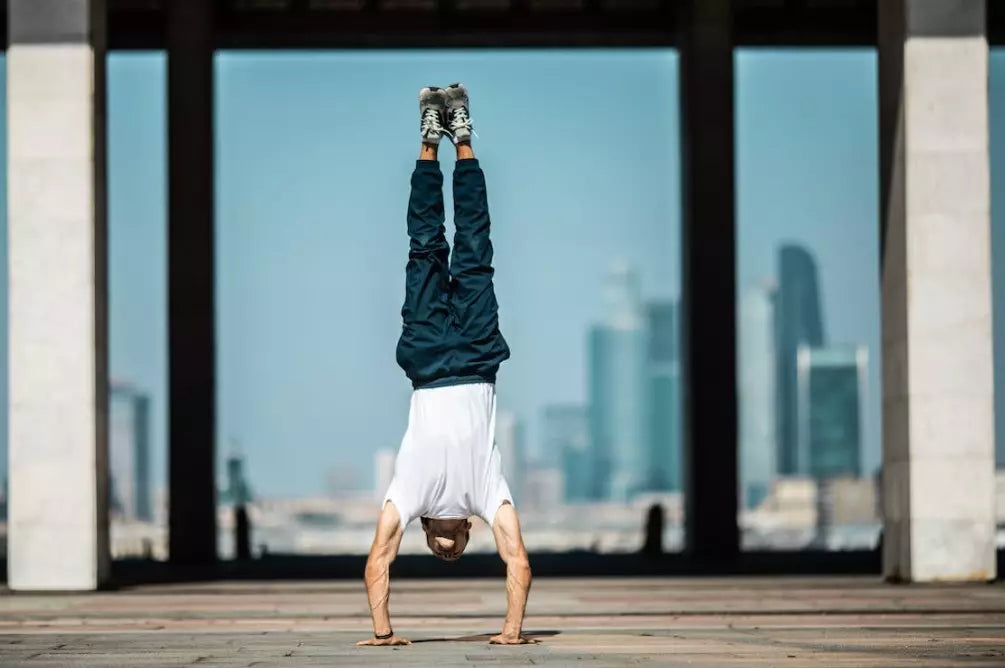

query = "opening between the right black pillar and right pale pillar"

[736,49,881,549]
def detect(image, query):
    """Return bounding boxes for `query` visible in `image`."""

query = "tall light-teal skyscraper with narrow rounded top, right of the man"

[589,262,649,500]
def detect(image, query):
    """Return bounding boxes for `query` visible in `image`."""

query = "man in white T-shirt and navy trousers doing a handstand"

[359,83,532,645]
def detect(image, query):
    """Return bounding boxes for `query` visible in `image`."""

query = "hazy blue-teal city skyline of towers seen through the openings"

[99,244,871,506]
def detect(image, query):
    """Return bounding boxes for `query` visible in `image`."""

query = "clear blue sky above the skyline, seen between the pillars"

[2,49,1005,495]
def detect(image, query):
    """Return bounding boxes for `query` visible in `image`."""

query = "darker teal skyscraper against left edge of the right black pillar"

[646,301,681,491]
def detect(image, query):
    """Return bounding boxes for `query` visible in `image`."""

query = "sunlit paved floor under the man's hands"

[0,578,1005,668]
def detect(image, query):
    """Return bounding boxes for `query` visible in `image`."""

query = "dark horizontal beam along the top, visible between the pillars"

[0,0,964,50]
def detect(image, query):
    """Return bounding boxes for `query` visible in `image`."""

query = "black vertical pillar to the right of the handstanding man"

[679,0,740,563]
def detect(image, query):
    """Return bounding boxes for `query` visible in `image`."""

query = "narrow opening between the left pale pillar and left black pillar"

[108,51,168,560]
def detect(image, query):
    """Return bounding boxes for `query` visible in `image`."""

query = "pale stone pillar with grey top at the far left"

[7,0,109,590]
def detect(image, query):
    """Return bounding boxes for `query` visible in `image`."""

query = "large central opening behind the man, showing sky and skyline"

[216,49,681,554]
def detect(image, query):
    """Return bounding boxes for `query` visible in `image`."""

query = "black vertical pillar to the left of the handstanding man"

[168,0,216,565]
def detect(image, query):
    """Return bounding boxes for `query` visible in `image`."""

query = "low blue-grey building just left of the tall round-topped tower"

[542,405,593,501]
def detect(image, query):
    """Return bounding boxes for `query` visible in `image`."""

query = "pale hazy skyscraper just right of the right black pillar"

[738,285,778,508]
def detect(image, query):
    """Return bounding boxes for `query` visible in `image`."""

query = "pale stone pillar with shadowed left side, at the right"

[878,0,995,582]
